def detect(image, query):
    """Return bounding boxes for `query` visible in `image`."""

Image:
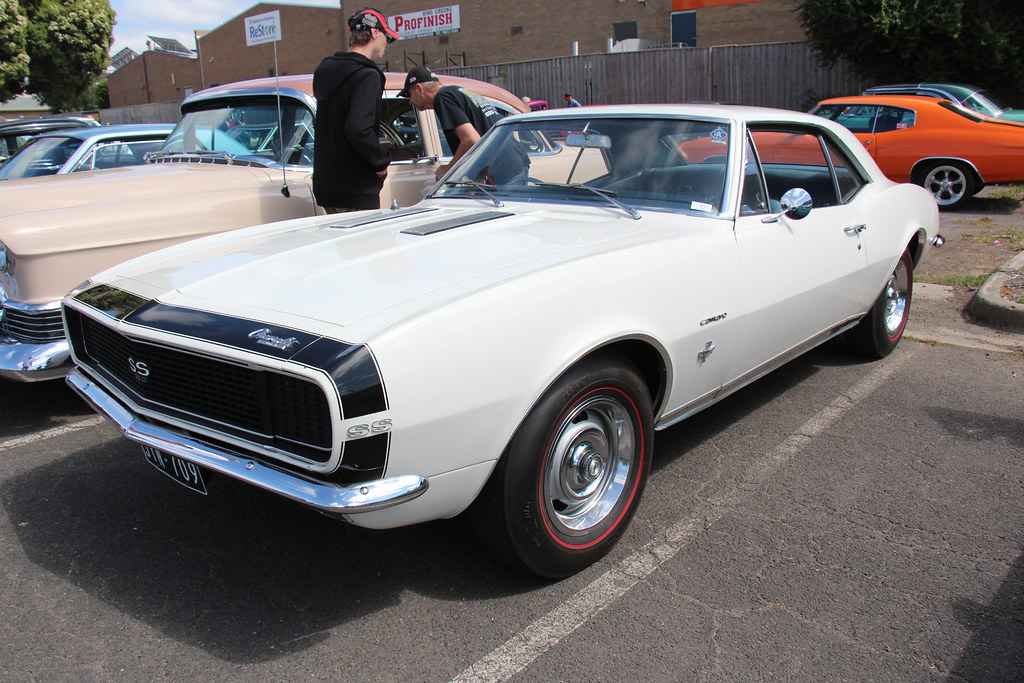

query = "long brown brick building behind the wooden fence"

[108,0,805,106]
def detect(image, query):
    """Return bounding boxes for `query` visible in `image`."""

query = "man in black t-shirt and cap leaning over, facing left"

[398,67,503,180]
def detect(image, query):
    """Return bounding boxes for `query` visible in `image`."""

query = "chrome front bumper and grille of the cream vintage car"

[0,288,71,382]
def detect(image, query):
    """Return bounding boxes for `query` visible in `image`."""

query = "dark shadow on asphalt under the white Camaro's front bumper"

[0,441,547,663]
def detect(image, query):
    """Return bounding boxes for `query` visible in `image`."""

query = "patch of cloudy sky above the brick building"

[111,0,339,54]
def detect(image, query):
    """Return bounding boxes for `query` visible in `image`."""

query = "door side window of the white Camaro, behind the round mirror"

[751,130,841,207]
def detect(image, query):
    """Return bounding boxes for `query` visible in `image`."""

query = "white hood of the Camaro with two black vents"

[94,201,679,340]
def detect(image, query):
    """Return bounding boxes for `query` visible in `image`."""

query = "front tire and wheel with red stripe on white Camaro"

[472,353,653,579]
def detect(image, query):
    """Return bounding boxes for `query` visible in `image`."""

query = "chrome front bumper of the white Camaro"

[67,370,429,516]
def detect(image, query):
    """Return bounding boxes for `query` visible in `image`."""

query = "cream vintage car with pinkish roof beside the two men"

[0,74,526,381]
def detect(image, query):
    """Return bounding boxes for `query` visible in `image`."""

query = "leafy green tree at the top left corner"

[0,0,114,112]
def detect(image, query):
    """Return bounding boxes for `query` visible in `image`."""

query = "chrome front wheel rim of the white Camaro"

[542,394,638,536]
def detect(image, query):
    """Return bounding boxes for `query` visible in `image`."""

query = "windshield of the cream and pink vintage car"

[157,100,313,164]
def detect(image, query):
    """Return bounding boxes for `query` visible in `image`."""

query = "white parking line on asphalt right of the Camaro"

[452,344,918,683]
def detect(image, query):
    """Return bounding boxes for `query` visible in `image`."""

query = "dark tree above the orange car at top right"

[799,0,1024,100]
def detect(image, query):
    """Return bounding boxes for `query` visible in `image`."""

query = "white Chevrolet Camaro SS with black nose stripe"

[63,105,941,578]
